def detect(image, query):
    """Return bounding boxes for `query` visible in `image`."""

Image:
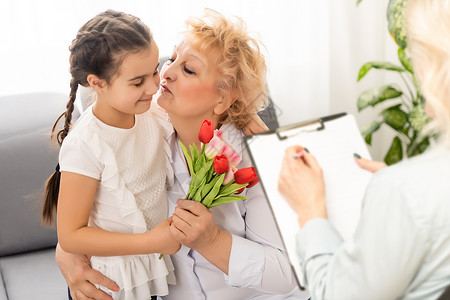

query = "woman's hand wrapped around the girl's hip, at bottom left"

[55,244,119,300]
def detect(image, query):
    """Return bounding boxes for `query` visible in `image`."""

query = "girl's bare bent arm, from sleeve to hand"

[57,172,180,256]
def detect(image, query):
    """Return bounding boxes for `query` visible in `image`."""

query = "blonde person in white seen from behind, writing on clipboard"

[278,0,450,300]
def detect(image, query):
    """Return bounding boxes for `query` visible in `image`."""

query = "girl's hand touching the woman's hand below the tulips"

[148,217,181,255]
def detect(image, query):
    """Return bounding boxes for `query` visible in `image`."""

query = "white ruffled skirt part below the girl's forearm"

[91,253,176,300]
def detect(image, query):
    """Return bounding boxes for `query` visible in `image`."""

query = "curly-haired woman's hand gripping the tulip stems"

[170,200,220,252]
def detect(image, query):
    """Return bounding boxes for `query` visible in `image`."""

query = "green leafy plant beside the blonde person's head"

[357,0,432,165]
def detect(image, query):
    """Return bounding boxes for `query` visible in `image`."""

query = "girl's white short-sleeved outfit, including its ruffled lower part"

[59,106,175,299]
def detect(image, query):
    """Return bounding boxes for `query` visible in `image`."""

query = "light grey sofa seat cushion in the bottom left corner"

[0,248,67,300]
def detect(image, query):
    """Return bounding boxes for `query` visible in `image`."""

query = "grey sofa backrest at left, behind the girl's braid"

[0,93,67,257]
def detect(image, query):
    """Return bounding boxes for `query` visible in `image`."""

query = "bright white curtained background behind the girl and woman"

[0,0,395,158]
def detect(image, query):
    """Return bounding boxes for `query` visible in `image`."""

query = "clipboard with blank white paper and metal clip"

[244,113,372,288]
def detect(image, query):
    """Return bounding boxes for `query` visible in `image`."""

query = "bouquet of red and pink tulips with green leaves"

[179,120,259,208]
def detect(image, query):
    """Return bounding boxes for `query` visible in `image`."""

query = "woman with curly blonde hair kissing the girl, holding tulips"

[57,10,306,300]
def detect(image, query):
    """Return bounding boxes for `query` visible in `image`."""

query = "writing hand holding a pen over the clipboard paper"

[278,146,327,226]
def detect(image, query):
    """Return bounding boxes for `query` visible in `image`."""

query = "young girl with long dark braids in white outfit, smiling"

[43,10,180,299]
